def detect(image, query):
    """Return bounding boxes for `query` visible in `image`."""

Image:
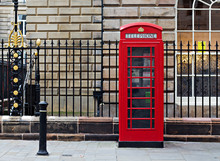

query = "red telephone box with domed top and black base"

[119,22,164,147]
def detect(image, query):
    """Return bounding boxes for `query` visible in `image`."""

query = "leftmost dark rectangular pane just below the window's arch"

[177,10,192,30]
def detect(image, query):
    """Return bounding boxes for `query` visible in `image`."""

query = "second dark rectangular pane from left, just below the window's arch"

[195,10,209,30]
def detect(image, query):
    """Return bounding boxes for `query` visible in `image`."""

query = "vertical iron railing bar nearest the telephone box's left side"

[115,40,118,117]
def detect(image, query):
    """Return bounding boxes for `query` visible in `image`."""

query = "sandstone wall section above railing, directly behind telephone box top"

[104,0,176,41]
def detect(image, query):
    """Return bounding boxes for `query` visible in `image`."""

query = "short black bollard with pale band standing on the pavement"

[37,101,49,155]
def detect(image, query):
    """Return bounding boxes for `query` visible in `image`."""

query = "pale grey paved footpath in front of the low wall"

[0,140,220,161]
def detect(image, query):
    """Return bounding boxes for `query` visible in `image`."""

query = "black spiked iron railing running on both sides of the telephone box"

[0,40,220,118]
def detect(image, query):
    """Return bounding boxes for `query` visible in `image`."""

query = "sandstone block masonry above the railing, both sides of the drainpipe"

[27,0,175,41]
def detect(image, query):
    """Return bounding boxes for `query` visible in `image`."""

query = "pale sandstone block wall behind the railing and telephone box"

[24,0,176,116]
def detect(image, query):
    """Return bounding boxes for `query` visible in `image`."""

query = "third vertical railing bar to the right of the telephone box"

[180,41,183,117]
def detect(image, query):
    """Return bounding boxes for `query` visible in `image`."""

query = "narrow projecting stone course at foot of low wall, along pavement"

[0,133,220,142]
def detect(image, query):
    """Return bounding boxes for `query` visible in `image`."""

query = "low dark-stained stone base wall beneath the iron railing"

[0,116,220,142]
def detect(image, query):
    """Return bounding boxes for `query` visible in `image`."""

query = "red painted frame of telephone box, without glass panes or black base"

[119,23,164,142]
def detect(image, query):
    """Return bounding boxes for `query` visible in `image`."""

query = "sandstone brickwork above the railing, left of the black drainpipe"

[27,0,101,40]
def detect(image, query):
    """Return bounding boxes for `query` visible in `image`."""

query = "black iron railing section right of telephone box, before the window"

[164,42,220,118]
